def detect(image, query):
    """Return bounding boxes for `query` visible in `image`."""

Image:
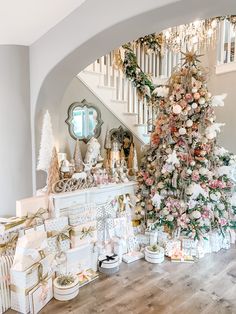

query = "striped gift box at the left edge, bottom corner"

[0,255,13,313]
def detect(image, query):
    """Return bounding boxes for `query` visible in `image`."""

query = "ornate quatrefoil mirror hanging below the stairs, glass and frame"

[66,99,103,143]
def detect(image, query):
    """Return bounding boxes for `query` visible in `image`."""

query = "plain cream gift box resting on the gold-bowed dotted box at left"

[12,231,48,271]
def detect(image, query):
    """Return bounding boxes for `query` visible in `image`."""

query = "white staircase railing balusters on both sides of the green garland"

[78,44,180,142]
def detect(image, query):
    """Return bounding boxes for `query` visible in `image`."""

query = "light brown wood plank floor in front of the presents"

[7,247,236,314]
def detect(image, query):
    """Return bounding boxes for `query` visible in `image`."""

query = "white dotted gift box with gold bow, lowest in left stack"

[11,255,53,314]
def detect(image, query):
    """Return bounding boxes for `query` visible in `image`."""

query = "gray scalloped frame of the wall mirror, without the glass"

[65,99,103,143]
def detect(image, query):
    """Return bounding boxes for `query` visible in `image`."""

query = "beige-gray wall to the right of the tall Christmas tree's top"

[202,49,236,154]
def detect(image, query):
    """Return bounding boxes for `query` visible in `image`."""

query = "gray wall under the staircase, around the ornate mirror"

[36,78,141,188]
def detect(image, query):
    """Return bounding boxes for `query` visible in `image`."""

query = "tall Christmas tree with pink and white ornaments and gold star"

[138,51,235,238]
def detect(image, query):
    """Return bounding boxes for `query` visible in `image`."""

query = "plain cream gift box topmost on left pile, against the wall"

[16,195,49,219]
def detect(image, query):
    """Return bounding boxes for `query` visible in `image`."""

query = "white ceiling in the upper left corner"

[0,0,86,45]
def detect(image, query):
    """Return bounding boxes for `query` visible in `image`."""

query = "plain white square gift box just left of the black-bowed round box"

[65,244,98,274]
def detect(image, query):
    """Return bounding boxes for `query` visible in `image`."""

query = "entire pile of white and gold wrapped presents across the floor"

[0,195,235,314]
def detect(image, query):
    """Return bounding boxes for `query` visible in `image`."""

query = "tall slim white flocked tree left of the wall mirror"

[37,110,54,172]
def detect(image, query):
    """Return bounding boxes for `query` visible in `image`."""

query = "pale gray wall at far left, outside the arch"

[0,46,32,216]
